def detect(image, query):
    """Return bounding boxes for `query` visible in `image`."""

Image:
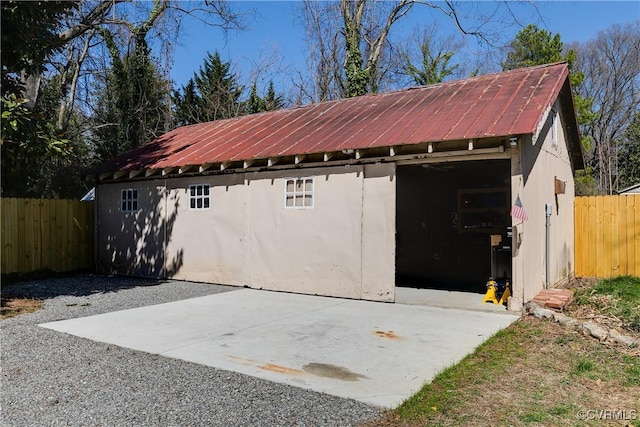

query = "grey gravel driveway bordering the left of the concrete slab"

[0,276,380,426]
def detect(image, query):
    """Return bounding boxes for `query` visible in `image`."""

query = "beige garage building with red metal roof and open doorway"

[89,63,583,309]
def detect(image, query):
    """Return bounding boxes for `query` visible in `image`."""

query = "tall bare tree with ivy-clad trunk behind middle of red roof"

[299,0,540,101]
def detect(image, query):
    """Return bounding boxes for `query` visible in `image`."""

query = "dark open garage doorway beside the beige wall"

[396,160,511,293]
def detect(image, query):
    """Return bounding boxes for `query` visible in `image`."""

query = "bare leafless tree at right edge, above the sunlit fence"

[575,21,640,194]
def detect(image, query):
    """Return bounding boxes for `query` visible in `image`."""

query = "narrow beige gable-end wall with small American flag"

[510,100,575,309]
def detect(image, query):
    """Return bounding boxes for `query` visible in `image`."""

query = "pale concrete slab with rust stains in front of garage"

[40,289,518,408]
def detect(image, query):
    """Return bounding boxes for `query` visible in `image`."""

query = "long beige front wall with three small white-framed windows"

[97,164,395,301]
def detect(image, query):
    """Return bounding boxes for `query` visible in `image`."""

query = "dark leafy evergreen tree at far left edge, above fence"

[0,1,76,197]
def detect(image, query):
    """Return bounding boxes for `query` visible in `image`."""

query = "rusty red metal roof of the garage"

[89,63,581,179]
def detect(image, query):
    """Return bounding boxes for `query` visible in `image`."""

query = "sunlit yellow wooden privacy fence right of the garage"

[574,194,640,277]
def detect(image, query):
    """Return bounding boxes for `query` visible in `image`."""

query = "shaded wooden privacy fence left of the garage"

[1,198,94,274]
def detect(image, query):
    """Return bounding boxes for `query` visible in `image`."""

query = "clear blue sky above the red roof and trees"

[171,0,640,95]
